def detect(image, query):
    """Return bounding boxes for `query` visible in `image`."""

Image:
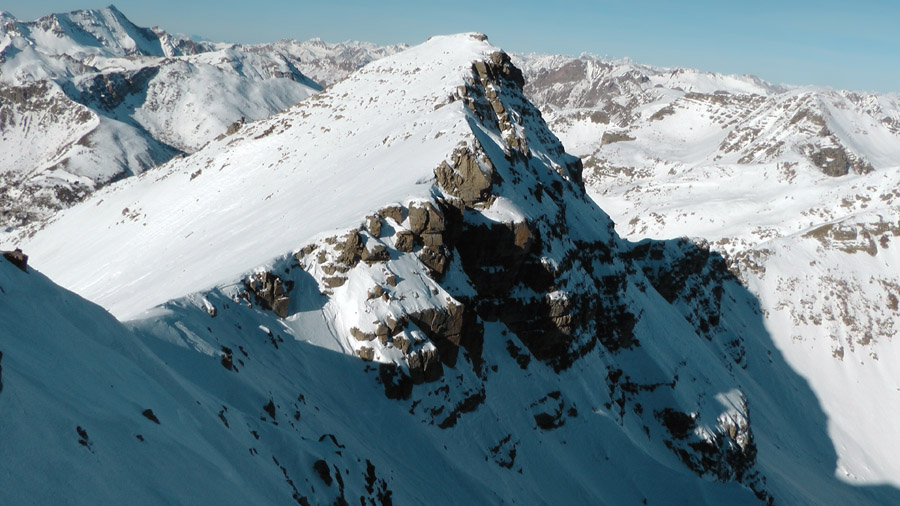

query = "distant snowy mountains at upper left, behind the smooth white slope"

[0,6,321,227]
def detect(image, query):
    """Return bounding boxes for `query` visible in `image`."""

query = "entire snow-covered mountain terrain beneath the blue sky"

[0,7,900,505]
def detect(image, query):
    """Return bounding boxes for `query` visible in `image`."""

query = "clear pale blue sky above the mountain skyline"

[7,0,900,92]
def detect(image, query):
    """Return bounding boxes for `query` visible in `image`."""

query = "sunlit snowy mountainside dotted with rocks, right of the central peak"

[522,51,900,485]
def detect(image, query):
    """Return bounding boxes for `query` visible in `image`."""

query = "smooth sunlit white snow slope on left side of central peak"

[19,34,512,317]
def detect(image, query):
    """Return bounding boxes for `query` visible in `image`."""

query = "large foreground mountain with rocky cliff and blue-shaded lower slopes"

[7,34,900,504]
